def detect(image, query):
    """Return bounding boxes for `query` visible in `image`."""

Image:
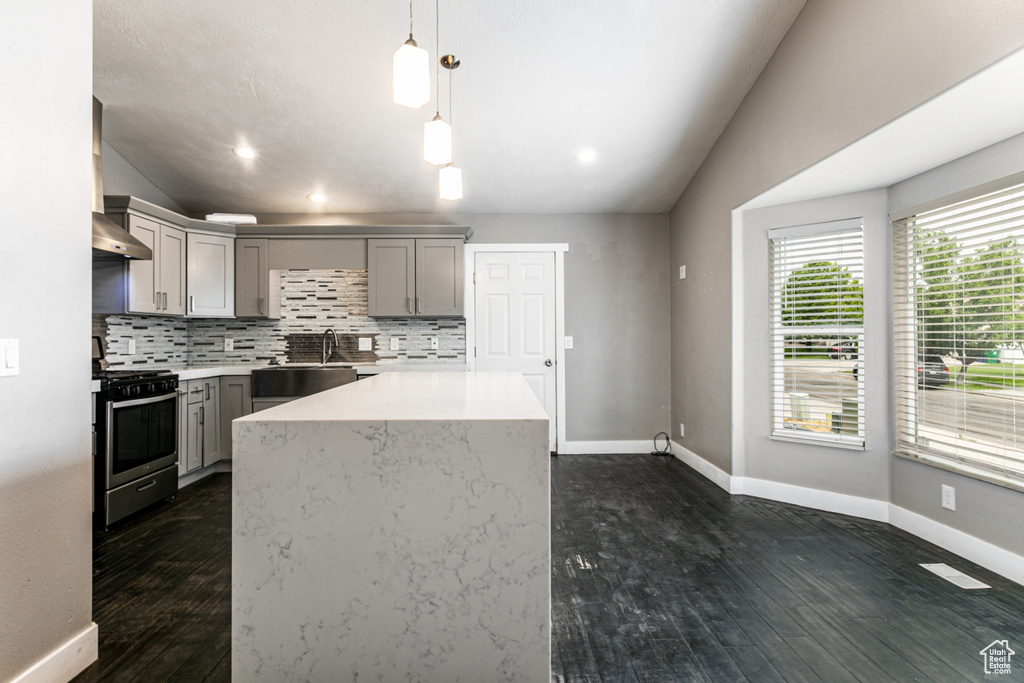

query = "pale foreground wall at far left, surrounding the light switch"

[0,0,92,681]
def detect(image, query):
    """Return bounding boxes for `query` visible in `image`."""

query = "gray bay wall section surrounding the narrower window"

[734,189,893,502]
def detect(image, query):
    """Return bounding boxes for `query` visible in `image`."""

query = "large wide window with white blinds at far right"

[893,185,1024,488]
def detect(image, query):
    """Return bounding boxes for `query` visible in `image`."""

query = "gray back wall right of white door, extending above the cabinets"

[244,214,670,441]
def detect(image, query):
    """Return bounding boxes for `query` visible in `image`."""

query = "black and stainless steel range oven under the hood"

[93,371,178,527]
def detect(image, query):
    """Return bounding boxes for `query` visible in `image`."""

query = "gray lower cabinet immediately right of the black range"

[178,377,220,475]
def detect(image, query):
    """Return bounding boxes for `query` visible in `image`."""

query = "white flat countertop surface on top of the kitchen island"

[237,372,548,422]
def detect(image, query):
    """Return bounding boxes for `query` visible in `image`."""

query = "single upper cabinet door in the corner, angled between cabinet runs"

[185,232,234,317]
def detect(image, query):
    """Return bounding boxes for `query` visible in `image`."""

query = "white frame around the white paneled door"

[463,243,569,453]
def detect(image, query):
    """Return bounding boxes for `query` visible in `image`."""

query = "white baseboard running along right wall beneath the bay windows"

[672,441,1024,585]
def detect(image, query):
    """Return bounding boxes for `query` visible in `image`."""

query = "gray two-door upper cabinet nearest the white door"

[367,238,464,317]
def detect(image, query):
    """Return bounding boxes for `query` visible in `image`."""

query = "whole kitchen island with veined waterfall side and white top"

[231,373,551,681]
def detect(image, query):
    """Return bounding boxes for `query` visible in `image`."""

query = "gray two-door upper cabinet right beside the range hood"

[128,214,185,315]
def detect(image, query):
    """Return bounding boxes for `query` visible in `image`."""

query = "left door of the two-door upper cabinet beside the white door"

[367,240,416,317]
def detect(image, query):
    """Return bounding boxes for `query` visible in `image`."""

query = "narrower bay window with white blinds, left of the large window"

[768,219,864,449]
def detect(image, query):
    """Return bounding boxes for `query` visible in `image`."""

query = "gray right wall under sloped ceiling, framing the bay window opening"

[670,0,1024,473]
